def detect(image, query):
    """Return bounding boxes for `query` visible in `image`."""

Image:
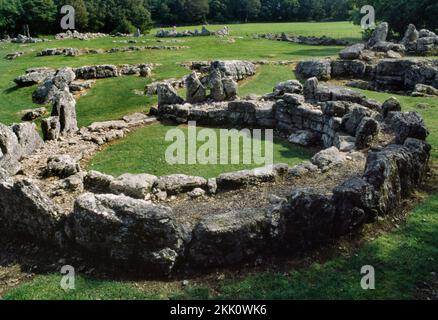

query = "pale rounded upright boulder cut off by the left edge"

[0,123,23,175]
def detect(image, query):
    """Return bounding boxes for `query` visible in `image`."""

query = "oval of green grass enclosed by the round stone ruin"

[89,124,312,178]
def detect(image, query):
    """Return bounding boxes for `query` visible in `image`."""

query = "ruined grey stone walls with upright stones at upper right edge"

[295,23,438,96]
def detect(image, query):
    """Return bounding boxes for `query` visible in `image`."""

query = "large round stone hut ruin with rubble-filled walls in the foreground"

[0,57,431,274]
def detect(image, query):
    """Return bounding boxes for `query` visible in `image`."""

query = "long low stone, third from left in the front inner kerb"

[154,174,207,195]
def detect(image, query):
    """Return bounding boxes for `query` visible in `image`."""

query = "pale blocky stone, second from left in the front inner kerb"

[109,173,157,200]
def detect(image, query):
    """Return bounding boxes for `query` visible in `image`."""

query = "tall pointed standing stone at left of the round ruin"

[52,88,78,135]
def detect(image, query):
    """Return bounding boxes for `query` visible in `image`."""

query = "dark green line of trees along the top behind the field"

[0,0,438,36]
